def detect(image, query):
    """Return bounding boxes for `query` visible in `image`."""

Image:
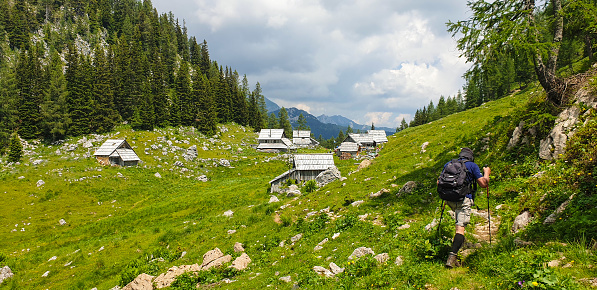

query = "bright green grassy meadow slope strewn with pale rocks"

[0,81,597,289]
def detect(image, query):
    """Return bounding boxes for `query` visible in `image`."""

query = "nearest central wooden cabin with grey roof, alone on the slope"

[269,153,336,192]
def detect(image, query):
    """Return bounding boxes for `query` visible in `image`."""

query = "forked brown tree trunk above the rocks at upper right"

[526,0,565,105]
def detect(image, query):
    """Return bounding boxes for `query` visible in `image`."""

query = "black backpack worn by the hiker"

[437,159,476,202]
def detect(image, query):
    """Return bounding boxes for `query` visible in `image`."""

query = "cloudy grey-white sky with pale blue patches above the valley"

[152,0,469,127]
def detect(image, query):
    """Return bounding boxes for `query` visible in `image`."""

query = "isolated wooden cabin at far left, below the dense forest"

[93,139,141,166]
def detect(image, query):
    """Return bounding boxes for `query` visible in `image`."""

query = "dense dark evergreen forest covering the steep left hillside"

[0,0,268,152]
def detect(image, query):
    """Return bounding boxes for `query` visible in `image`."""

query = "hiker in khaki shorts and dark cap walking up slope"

[437,147,491,268]
